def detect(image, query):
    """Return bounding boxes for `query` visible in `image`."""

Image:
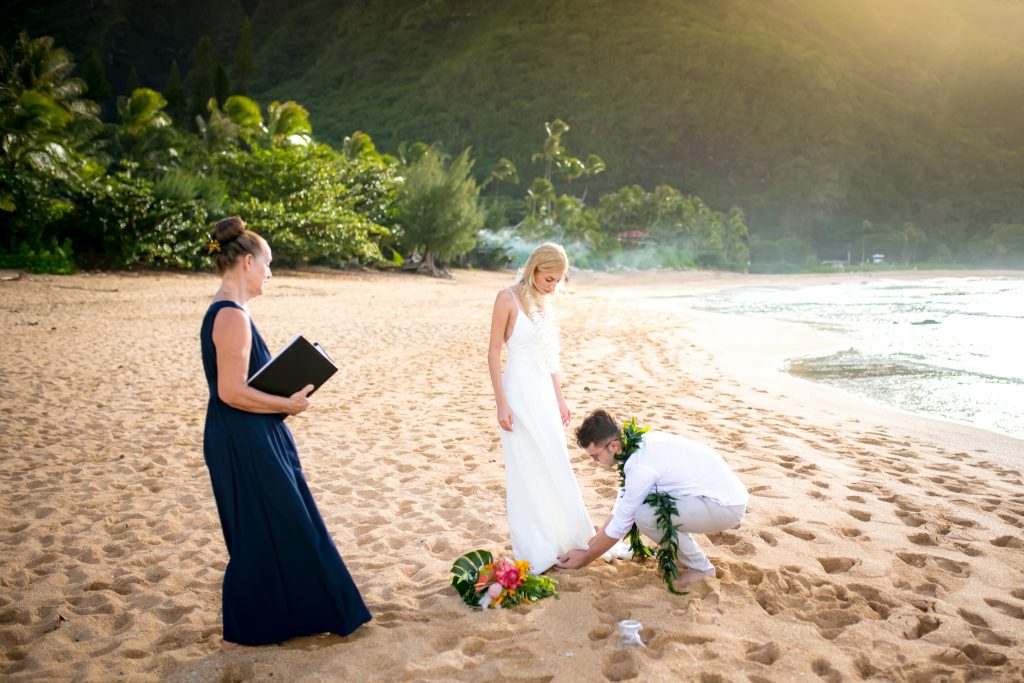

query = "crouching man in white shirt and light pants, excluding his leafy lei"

[555,410,750,584]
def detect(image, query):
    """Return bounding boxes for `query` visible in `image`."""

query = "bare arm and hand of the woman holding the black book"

[213,308,313,415]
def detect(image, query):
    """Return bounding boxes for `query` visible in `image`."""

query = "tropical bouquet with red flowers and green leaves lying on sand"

[452,550,558,609]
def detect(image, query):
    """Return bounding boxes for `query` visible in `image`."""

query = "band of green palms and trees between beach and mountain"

[0,29,749,274]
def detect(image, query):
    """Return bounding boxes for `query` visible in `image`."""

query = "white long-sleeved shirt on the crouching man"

[604,432,751,539]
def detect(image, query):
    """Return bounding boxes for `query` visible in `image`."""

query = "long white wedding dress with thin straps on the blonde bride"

[499,296,594,573]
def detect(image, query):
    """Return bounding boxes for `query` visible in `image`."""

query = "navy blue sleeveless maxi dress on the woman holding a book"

[200,301,371,645]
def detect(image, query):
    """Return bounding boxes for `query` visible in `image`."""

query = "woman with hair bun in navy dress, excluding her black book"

[200,217,371,645]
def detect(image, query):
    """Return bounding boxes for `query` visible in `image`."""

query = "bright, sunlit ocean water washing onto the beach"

[691,278,1024,438]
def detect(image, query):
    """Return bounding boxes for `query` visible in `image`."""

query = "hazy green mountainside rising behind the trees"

[0,0,1024,256]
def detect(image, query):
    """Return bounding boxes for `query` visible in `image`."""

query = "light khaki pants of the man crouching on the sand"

[634,496,746,571]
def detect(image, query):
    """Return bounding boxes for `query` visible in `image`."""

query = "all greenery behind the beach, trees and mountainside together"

[0,0,1024,272]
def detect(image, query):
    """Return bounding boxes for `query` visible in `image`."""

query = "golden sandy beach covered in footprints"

[0,271,1024,683]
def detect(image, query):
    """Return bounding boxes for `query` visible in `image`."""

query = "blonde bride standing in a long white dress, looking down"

[487,243,594,573]
